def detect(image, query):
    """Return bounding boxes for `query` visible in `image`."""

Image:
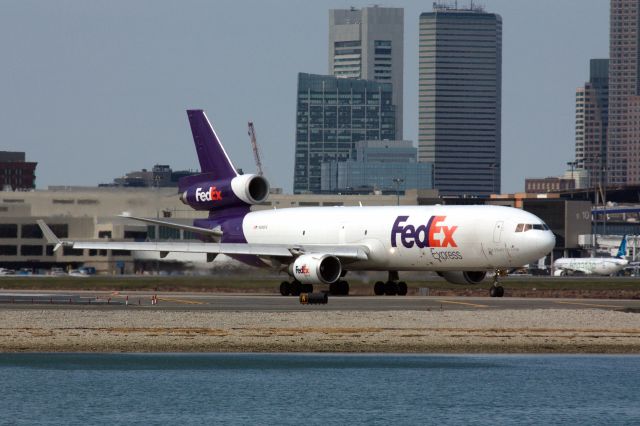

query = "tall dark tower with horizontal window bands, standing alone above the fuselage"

[418,4,502,196]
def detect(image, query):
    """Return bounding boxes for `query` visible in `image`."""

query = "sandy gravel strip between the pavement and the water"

[0,309,640,353]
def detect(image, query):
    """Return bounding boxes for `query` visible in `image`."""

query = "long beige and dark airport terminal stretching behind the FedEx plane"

[0,187,620,274]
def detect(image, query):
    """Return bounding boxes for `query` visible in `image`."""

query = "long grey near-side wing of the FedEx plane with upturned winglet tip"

[37,220,368,260]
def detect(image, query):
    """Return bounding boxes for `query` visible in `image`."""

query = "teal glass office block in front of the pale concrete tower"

[293,73,396,194]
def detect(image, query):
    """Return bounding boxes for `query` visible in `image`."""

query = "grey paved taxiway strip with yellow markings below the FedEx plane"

[0,290,640,312]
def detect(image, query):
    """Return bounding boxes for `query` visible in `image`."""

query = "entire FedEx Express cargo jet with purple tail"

[39,110,555,297]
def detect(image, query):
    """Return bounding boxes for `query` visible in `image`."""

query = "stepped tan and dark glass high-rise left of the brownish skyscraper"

[576,59,609,186]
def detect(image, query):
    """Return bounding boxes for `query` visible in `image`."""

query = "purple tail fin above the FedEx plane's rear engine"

[187,109,238,180]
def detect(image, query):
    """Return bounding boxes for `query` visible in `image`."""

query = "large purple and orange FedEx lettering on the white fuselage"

[391,216,458,248]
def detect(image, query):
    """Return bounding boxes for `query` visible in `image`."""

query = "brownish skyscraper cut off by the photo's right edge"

[605,0,640,184]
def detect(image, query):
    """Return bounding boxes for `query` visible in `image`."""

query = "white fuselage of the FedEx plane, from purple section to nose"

[243,205,555,271]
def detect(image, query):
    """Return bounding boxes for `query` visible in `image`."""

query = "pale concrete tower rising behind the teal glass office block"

[329,6,404,140]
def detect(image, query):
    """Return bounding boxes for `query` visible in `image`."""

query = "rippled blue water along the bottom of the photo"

[0,354,640,425]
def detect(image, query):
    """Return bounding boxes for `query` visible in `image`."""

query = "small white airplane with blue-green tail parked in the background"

[553,235,629,276]
